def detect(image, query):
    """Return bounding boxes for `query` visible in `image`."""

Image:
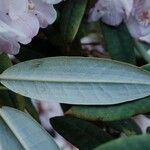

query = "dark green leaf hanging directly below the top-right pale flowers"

[101,23,136,64]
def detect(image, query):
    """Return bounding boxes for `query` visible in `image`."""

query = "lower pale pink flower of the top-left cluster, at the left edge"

[0,12,39,54]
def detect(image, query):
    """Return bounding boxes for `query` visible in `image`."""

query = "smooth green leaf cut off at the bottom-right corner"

[95,135,150,150]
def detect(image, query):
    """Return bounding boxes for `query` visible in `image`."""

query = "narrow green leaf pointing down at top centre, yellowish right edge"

[60,0,87,43]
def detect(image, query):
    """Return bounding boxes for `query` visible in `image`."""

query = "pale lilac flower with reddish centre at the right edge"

[126,0,150,42]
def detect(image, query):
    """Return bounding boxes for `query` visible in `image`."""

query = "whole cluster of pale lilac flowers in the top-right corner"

[89,0,150,43]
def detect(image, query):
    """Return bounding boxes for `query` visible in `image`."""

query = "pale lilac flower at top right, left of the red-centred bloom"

[89,0,133,26]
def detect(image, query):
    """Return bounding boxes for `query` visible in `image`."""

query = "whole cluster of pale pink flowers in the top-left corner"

[0,0,61,54]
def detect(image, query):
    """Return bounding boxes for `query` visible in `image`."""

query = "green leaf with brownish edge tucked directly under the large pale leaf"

[66,97,150,121]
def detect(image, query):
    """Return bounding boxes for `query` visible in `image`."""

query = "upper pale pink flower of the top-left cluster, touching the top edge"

[4,0,61,27]
